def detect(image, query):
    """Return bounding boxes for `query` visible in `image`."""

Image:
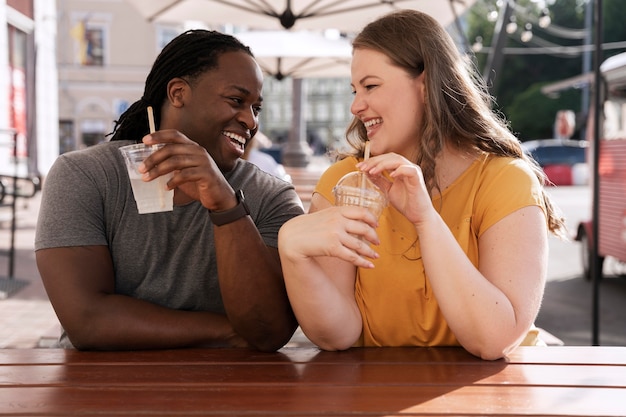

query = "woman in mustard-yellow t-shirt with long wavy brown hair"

[279,10,564,359]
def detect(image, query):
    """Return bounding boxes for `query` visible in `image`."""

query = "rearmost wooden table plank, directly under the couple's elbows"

[0,346,626,366]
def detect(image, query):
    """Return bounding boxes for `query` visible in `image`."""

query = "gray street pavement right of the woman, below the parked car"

[536,186,626,346]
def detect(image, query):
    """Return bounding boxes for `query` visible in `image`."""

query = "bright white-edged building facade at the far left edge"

[0,0,58,177]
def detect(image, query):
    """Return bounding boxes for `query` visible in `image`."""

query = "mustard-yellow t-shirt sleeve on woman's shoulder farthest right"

[474,158,546,236]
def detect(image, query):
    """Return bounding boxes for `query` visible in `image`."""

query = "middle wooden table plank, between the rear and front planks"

[0,363,626,389]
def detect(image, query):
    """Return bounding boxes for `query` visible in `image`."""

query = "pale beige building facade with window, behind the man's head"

[57,0,176,153]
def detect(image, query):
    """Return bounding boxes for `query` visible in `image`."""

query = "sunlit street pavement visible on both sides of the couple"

[0,179,626,348]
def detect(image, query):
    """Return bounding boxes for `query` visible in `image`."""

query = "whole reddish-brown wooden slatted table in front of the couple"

[0,347,626,416]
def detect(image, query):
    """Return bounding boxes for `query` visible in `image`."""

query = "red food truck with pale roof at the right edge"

[576,53,626,279]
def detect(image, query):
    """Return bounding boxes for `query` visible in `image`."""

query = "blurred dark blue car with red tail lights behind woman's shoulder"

[522,139,589,185]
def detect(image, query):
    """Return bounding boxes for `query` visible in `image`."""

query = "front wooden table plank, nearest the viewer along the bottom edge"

[0,384,626,416]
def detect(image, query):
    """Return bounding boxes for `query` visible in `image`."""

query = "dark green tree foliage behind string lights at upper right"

[467,0,626,140]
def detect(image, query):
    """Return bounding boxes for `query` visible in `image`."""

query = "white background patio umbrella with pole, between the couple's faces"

[235,30,352,166]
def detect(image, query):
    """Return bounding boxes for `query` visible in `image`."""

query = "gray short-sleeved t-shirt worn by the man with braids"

[35,141,303,344]
